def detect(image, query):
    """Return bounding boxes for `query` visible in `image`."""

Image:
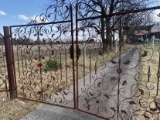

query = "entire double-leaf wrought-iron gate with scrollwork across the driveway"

[4,4,160,120]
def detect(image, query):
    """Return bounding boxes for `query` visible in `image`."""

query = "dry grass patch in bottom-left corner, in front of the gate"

[0,99,38,120]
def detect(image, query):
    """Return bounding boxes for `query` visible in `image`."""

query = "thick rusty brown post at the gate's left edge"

[3,26,17,99]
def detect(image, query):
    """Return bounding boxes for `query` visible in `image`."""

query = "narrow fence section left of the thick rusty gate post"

[0,34,9,102]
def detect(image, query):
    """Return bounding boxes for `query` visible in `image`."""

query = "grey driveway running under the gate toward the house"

[21,47,139,120]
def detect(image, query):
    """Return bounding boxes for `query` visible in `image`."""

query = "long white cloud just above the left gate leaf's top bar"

[18,15,49,23]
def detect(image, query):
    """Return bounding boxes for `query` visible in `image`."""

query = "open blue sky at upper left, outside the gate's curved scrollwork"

[0,0,51,33]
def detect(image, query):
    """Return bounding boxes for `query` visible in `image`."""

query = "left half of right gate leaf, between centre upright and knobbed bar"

[77,18,126,120]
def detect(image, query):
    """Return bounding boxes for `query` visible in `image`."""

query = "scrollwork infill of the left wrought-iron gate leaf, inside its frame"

[11,6,75,108]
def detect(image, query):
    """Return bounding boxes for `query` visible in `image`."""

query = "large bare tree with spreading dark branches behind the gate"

[42,0,156,51]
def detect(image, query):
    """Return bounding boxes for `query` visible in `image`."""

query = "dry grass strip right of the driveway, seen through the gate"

[137,44,160,120]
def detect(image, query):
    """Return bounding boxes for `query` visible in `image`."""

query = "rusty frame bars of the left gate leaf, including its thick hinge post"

[4,5,78,109]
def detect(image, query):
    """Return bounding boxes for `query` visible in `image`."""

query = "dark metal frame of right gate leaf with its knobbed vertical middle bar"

[75,3,160,120]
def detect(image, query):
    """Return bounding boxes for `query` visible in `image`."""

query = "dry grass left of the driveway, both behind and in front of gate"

[0,45,130,120]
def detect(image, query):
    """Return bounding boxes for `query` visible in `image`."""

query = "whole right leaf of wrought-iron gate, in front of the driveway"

[76,3,160,120]
